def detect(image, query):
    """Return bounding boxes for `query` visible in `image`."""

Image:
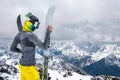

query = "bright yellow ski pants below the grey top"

[18,64,40,80]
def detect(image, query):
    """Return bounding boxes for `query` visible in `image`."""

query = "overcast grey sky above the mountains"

[0,0,120,41]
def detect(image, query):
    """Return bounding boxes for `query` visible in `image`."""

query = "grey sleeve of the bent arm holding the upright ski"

[29,30,51,50]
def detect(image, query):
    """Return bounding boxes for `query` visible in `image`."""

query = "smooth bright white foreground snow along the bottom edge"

[1,69,92,80]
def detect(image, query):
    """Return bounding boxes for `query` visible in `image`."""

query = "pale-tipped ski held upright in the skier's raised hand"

[43,5,55,80]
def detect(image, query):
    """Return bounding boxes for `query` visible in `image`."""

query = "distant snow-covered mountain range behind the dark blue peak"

[51,41,120,67]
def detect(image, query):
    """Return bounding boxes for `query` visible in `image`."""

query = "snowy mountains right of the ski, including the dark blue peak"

[51,41,120,76]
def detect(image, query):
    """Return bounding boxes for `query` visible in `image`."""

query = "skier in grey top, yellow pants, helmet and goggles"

[10,13,53,80]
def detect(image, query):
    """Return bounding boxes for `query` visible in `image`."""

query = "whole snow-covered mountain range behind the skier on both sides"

[0,39,120,80]
